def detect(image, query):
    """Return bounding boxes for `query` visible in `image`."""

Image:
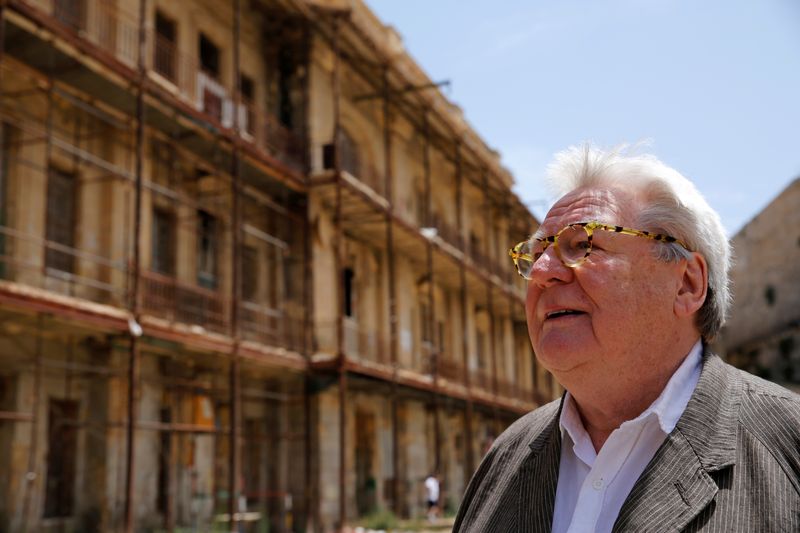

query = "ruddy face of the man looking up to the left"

[525,188,680,388]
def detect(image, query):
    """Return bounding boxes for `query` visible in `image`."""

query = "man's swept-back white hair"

[547,143,731,342]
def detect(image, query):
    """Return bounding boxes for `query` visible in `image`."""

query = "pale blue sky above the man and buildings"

[366,0,800,236]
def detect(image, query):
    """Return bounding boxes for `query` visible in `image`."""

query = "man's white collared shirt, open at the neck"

[553,340,703,533]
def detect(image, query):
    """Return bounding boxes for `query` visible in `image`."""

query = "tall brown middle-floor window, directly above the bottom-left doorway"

[45,167,76,272]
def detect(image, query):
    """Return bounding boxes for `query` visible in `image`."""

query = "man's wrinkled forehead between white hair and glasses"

[533,187,636,238]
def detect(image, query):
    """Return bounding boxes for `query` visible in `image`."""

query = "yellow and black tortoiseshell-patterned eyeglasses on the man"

[508,221,689,280]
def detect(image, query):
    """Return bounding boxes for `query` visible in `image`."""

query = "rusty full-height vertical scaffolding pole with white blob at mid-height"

[125,0,147,533]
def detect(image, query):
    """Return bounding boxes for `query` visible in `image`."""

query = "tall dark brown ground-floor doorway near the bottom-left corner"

[44,399,78,518]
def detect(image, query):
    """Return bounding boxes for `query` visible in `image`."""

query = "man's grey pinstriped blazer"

[453,352,800,533]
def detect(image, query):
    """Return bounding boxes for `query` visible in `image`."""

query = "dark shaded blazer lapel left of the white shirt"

[516,406,563,533]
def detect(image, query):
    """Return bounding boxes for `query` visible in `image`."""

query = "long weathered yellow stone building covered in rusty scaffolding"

[0,0,558,531]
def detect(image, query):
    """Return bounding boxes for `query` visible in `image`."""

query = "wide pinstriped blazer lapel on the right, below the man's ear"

[613,352,740,531]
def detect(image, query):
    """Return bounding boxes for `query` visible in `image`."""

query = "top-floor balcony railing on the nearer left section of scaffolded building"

[22,0,306,171]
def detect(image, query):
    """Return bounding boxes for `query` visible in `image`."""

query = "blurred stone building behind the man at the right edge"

[719,178,800,391]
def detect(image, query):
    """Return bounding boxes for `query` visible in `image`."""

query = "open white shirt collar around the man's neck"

[558,339,703,446]
